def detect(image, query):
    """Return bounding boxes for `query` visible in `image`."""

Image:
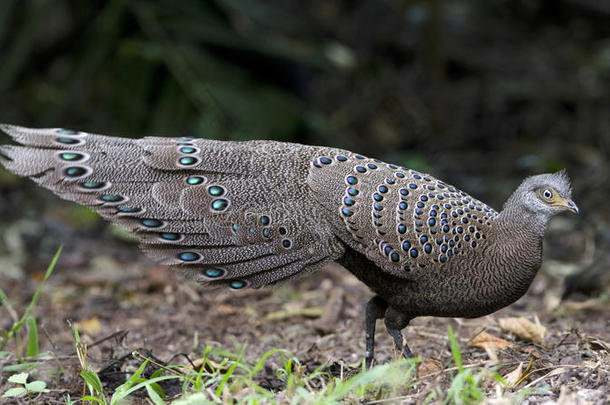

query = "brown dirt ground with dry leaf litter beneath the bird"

[0,197,610,404]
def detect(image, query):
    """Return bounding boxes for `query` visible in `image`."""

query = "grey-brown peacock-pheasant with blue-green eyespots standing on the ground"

[0,124,579,368]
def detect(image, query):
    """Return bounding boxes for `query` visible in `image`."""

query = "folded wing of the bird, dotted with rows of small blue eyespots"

[308,151,497,279]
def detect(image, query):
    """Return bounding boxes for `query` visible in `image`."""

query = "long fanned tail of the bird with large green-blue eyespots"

[0,125,344,289]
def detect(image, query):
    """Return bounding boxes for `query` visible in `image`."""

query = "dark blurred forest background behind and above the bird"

[0,0,610,268]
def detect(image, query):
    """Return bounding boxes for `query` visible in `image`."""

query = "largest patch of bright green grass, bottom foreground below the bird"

[66,338,417,405]
